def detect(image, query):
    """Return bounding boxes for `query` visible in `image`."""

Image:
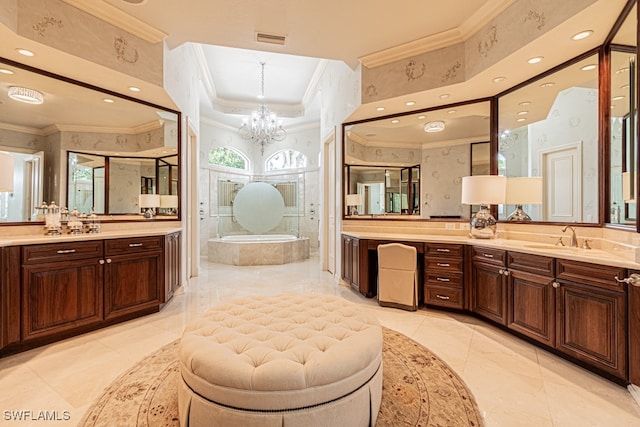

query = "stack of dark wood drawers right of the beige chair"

[424,243,464,309]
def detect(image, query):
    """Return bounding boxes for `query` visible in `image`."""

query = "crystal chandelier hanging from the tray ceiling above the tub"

[239,62,287,155]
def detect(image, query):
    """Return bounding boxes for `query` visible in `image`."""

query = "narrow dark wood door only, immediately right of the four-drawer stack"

[470,261,507,325]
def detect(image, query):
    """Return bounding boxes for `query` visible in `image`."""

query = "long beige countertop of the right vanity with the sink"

[342,231,640,270]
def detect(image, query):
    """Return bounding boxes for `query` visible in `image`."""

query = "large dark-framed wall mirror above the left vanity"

[0,58,180,224]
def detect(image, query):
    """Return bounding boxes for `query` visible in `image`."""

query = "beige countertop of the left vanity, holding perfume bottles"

[0,226,182,247]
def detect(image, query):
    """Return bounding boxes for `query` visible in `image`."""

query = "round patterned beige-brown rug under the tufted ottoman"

[78,328,482,427]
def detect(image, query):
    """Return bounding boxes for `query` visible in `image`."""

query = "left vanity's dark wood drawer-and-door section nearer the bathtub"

[104,236,165,319]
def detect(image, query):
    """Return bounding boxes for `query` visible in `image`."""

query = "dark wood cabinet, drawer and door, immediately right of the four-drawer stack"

[468,246,507,325]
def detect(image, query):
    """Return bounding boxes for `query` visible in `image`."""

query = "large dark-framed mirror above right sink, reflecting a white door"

[498,54,599,223]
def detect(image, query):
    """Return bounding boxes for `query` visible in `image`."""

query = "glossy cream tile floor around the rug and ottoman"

[0,257,640,427]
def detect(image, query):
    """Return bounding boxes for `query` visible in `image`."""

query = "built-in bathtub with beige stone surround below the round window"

[207,234,309,265]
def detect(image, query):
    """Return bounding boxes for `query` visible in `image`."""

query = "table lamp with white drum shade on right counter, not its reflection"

[462,175,507,239]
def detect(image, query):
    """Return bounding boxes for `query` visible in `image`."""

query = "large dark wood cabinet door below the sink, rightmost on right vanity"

[556,280,627,378]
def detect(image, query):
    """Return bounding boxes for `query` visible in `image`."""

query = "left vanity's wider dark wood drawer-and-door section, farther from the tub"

[21,241,104,341]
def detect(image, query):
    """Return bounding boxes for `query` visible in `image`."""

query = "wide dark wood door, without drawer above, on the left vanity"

[22,259,103,341]
